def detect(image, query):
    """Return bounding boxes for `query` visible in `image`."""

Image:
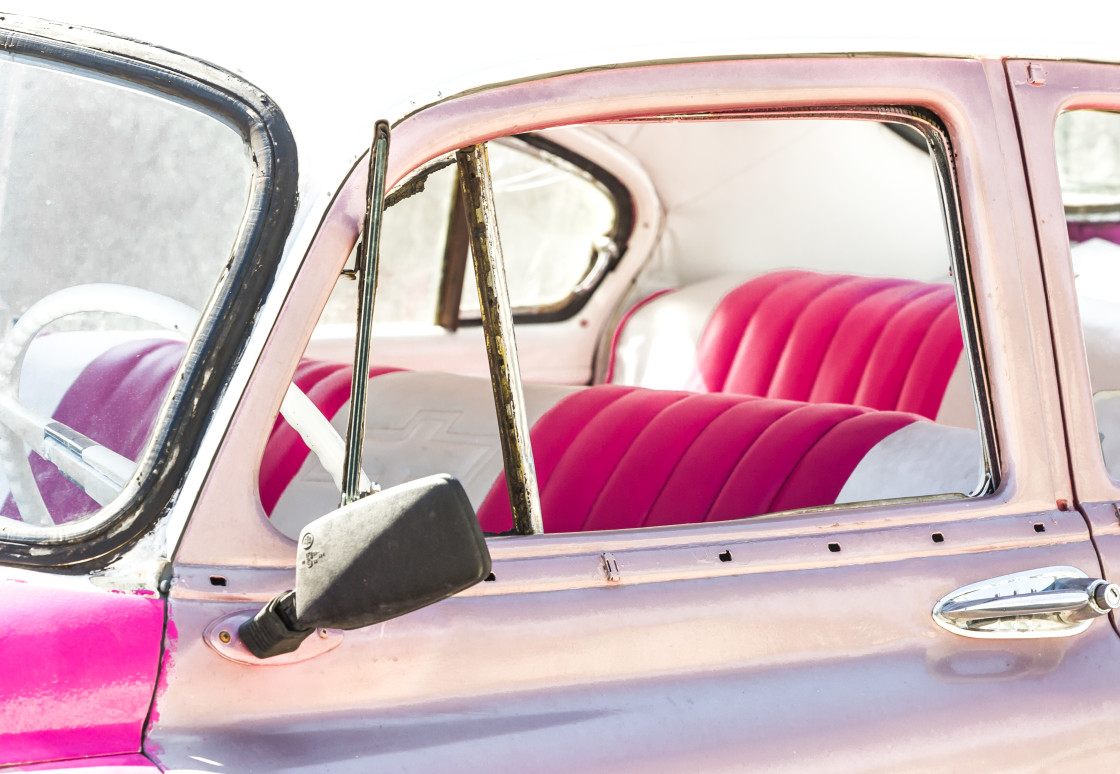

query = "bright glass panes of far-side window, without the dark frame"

[321,138,617,325]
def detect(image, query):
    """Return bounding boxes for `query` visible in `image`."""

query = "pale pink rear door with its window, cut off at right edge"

[1007,59,1120,622]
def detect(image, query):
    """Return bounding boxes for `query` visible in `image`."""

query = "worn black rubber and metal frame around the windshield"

[0,15,297,573]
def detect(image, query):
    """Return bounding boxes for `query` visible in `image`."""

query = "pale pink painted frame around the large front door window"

[180,56,1068,568]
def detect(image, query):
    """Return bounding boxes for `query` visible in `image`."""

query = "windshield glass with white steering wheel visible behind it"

[0,52,251,528]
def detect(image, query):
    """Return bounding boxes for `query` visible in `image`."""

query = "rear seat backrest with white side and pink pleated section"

[608,270,963,419]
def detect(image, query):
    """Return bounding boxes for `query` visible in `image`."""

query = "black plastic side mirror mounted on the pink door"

[237,475,491,659]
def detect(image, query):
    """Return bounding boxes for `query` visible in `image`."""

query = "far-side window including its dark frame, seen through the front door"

[323,136,632,329]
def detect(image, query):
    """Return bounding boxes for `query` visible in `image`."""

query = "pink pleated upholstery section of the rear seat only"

[615,269,963,419]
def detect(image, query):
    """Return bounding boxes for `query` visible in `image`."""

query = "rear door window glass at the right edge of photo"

[1054,110,1120,481]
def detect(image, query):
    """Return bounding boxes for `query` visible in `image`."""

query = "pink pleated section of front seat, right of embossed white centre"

[478,384,920,532]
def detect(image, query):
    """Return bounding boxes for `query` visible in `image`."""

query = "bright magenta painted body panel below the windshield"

[0,572,164,765]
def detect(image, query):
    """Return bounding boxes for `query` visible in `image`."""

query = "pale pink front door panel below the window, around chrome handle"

[148,512,1120,772]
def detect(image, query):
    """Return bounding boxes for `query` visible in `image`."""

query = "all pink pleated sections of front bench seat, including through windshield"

[13,329,936,532]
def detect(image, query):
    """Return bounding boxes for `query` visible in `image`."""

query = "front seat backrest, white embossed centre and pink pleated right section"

[267,371,978,535]
